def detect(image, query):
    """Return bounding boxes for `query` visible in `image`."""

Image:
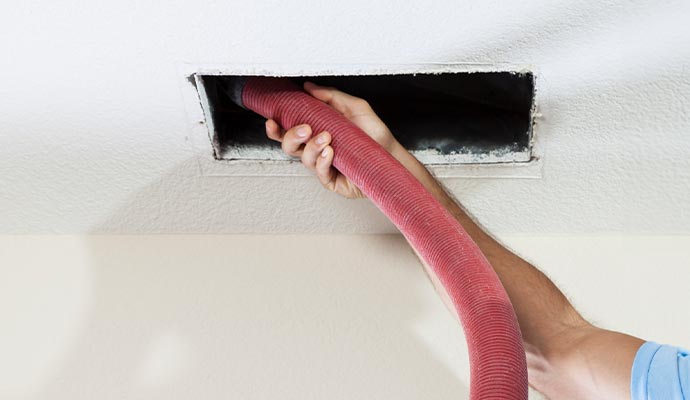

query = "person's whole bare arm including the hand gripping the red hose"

[266,84,643,399]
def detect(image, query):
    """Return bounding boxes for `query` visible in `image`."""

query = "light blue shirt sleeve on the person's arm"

[630,342,690,400]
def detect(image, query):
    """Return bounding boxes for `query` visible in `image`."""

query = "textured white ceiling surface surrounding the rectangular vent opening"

[0,0,690,233]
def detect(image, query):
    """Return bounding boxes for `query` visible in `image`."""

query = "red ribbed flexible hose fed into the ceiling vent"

[241,77,527,400]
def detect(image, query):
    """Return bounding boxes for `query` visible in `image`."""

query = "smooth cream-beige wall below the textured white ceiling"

[0,236,690,400]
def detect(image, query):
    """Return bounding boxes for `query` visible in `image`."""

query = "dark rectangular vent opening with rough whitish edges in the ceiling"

[197,72,535,165]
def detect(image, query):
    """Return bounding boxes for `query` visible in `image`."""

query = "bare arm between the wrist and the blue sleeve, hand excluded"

[391,141,643,399]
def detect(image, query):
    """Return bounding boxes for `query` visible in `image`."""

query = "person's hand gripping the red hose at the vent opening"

[266,82,398,199]
